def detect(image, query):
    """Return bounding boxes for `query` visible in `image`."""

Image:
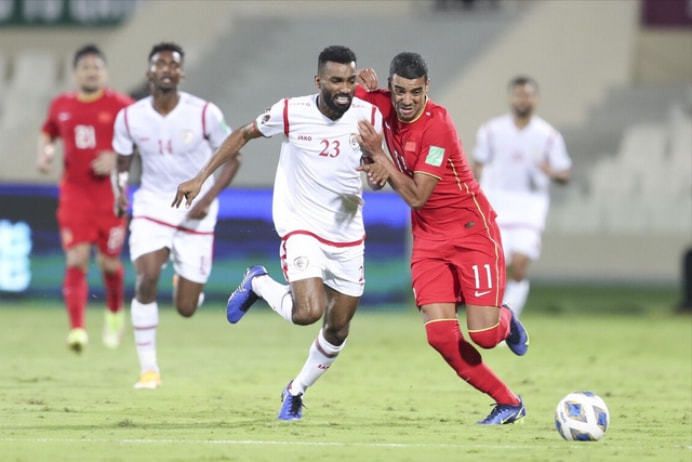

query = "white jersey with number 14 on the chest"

[113,92,231,231]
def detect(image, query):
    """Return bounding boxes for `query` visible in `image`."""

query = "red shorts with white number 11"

[411,219,506,306]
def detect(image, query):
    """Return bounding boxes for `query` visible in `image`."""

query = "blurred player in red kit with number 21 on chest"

[37,45,132,352]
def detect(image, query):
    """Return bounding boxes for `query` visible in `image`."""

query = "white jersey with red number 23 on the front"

[256,94,382,244]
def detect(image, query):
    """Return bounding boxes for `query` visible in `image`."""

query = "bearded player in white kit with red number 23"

[173,46,382,420]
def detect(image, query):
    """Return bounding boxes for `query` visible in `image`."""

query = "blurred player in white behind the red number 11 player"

[473,76,572,316]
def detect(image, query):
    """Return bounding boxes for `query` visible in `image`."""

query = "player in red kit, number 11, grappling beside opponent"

[356,52,528,425]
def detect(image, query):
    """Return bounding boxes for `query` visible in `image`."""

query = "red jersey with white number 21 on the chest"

[42,89,132,209]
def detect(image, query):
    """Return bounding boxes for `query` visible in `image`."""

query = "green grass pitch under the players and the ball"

[0,287,692,462]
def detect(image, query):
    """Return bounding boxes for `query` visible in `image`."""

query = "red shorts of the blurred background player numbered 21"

[56,203,126,257]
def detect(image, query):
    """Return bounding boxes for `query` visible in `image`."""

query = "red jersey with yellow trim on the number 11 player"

[356,86,486,240]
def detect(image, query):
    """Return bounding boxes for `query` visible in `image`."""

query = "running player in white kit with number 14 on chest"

[113,43,239,389]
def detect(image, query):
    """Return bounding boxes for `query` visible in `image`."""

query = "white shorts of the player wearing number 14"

[130,218,214,284]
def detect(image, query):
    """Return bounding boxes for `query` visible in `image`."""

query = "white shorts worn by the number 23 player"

[279,234,365,297]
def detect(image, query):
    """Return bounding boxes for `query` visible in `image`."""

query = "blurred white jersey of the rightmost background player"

[473,114,572,230]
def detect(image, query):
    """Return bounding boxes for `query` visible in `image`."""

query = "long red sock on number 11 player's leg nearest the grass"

[425,319,519,405]
